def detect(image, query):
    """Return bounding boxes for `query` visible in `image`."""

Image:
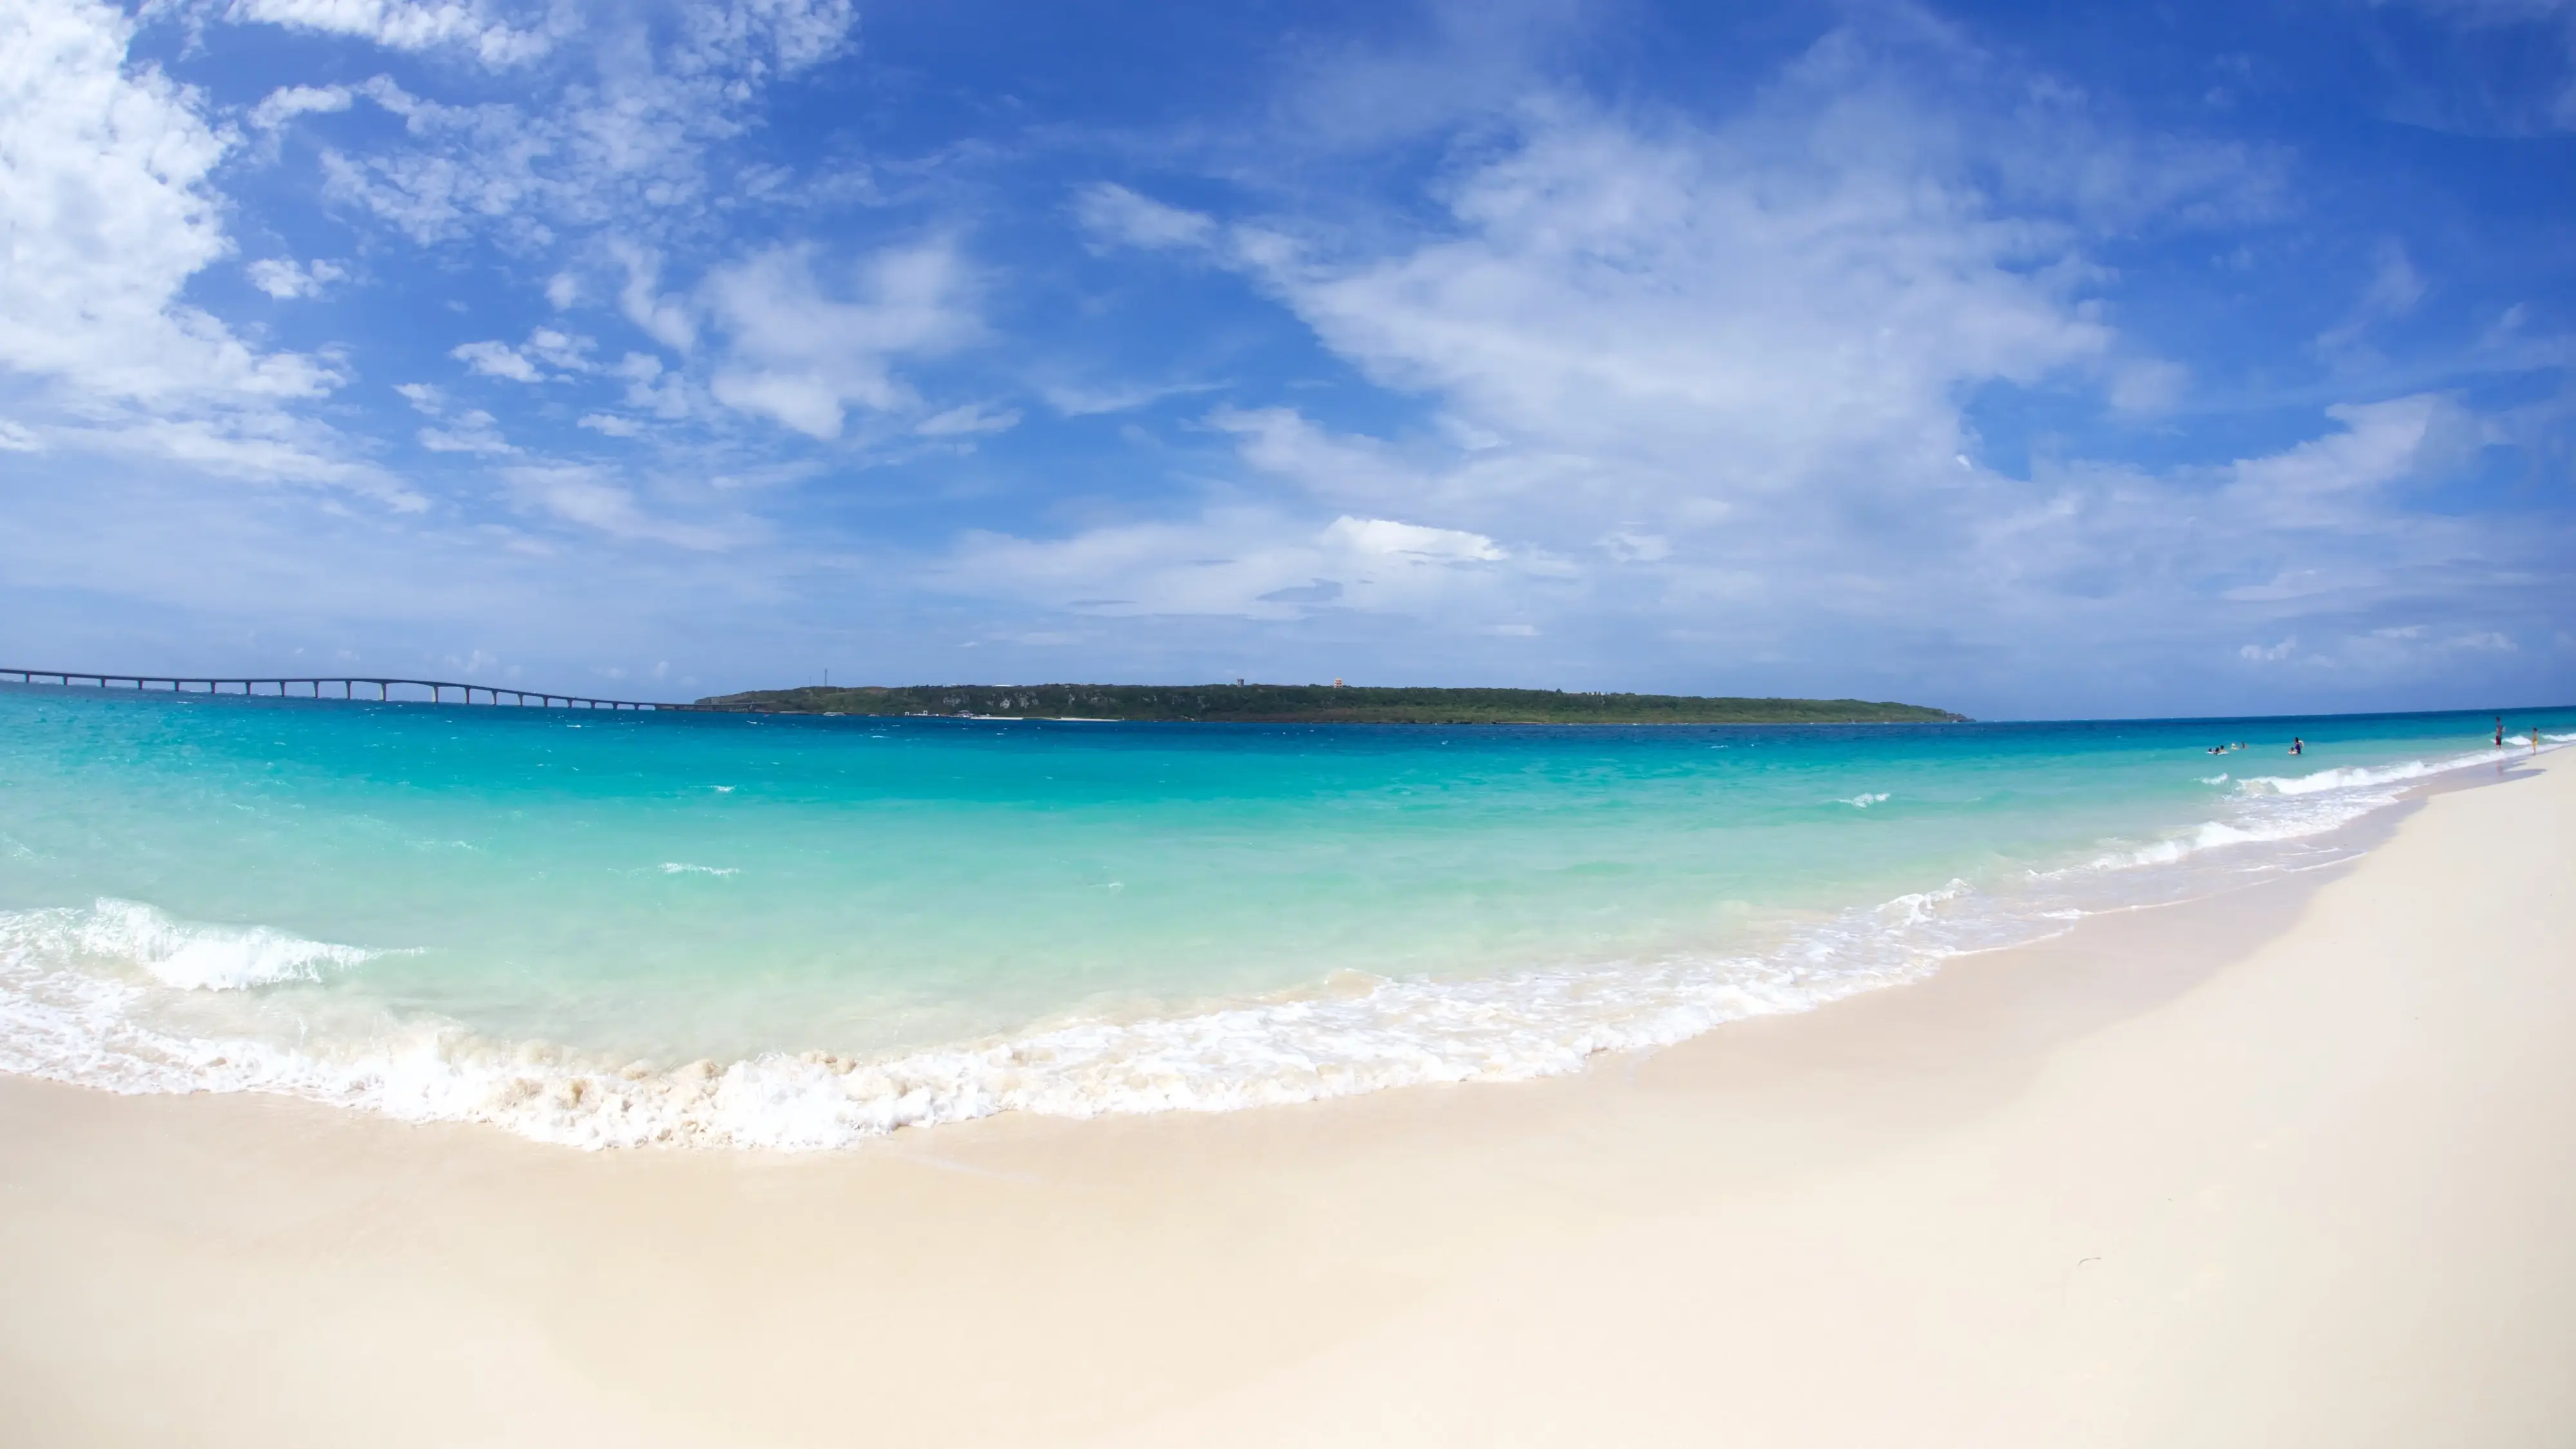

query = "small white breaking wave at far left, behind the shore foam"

[0,897,384,990]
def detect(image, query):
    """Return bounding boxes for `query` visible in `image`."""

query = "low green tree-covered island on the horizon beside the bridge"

[698,683,1968,724]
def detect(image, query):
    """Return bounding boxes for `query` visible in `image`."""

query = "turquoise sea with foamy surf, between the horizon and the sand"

[0,688,2576,1150]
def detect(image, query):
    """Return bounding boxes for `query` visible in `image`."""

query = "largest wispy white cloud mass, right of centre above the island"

[943,15,2339,660]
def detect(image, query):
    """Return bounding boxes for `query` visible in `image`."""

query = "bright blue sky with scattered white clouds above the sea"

[0,0,2576,717]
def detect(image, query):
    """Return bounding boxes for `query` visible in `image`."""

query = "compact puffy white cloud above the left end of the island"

[701,240,981,439]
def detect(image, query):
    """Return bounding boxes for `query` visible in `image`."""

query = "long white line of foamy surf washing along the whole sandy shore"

[0,745,2555,1150]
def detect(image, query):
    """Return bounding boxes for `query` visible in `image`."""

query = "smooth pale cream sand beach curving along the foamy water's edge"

[0,761,2576,1449]
